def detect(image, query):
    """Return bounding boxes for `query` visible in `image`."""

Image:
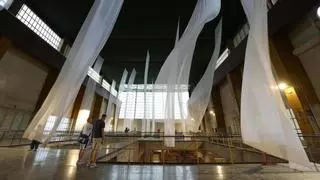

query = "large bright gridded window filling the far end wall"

[119,84,189,120]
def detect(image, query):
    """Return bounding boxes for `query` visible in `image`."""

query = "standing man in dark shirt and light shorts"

[88,114,107,168]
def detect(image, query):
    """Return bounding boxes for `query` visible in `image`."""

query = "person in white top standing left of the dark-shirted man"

[77,117,93,165]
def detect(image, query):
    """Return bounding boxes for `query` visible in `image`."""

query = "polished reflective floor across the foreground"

[0,148,320,180]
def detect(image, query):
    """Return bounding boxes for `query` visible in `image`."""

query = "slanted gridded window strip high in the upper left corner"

[17,4,61,50]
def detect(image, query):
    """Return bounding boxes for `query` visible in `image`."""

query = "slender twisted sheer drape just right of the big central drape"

[188,20,222,132]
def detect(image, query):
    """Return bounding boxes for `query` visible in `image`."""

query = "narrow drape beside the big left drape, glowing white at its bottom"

[75,56,104,131]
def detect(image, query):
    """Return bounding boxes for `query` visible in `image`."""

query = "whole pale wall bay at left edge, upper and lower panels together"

[0,48,47,129]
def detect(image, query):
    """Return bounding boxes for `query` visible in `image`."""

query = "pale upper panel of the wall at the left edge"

[0,49,47,111]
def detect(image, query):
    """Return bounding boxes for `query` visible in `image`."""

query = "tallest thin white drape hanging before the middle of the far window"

[142,51,150,132]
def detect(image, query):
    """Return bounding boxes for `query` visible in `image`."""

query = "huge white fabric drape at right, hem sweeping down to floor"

[241,0,312,170]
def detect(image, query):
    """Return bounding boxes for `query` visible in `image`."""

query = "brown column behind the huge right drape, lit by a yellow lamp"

[270,32,320,134]
